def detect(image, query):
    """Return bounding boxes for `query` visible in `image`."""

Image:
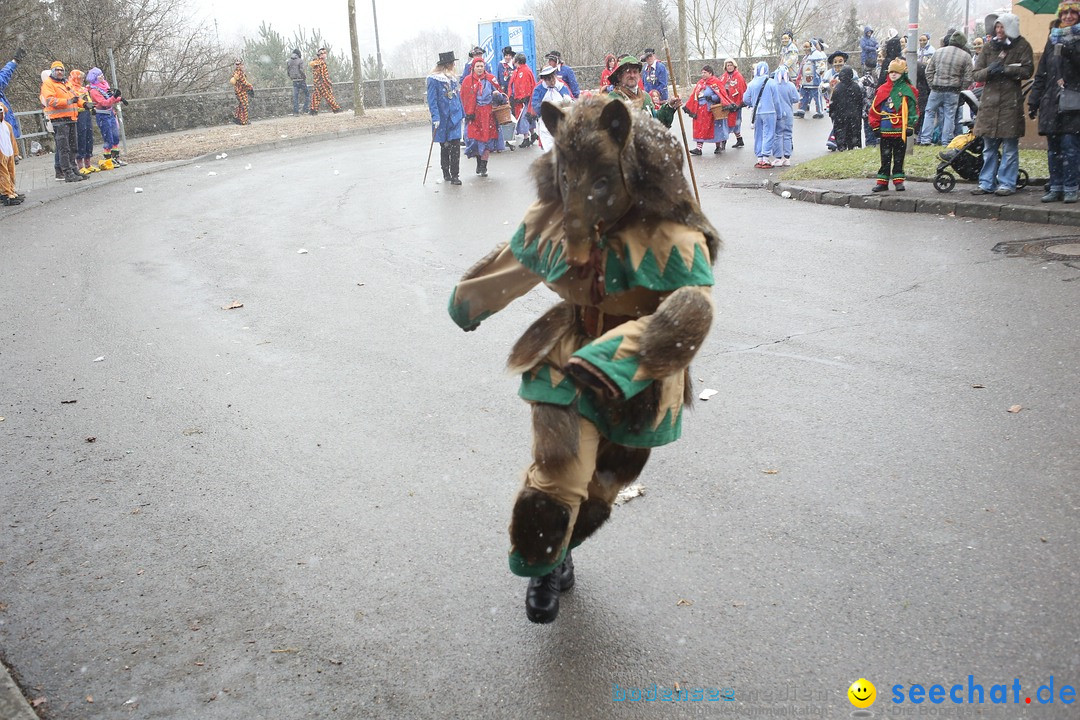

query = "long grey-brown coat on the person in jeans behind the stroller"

[971,37,1035,137]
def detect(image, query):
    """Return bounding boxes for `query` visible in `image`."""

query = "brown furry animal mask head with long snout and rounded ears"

[540,97,635,267]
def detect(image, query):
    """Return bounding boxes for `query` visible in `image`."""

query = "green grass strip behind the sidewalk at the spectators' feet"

[780,146,1050,180]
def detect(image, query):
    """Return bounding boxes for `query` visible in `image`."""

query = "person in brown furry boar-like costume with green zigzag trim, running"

[448,96,720,623]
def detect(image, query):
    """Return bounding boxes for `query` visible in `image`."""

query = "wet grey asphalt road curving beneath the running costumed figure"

[0,120,1080,719]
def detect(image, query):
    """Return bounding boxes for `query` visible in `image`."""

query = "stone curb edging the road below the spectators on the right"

[765,178,1080,227]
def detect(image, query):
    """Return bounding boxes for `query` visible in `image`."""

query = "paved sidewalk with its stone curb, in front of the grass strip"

[766,179,1080,226]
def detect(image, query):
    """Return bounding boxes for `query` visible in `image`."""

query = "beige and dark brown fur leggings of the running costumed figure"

[510,403,649,576]
